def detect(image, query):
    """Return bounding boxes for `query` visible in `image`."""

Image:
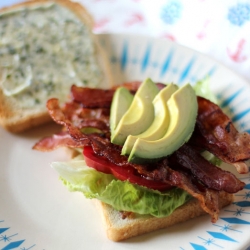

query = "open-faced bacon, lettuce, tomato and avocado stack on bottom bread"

[33,79,250,241]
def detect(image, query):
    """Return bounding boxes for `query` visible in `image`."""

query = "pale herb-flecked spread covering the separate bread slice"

[0,3,103,108]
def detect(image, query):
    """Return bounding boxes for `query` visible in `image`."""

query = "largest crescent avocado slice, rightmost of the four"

[128,84,198,163]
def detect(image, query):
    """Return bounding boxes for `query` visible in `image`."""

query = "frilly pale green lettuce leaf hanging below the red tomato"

[52,159,191,217]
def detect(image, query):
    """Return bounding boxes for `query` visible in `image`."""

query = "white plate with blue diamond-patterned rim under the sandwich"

[0,35,250,250]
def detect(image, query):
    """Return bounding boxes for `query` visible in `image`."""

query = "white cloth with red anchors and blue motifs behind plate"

[0,0,250,82]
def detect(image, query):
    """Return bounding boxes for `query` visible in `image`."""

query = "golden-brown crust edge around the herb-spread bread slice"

[0,0,114,133]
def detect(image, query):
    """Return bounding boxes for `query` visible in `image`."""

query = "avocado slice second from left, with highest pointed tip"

[111,78,159,145]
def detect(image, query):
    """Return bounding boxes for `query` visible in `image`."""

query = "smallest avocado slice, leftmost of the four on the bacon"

[109,87,134,134]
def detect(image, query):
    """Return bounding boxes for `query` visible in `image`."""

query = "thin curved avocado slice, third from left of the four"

[122,83,178,155]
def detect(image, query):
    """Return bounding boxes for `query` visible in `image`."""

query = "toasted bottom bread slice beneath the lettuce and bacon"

[98,192,233,241]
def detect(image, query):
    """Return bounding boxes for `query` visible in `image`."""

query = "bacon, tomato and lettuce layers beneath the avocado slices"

[34,83,250,222]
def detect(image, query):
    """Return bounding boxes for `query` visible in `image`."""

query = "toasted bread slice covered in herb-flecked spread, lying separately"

[0,0,114,132]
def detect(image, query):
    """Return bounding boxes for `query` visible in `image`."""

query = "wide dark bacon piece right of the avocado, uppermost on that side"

[190,97,250,173]
